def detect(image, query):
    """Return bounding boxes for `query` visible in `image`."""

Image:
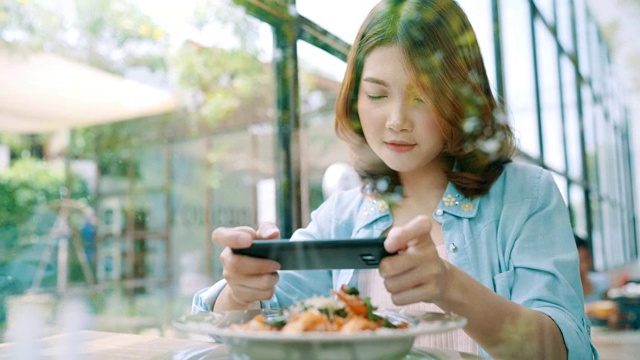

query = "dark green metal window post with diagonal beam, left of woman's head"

[234,0,350,237]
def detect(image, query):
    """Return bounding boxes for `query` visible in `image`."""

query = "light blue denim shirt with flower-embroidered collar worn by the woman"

[193,163,598,360]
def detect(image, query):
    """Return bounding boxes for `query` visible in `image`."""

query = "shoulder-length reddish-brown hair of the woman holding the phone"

[335,0,515,197]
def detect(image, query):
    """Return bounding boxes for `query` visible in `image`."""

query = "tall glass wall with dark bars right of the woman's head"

[500,0,637,270]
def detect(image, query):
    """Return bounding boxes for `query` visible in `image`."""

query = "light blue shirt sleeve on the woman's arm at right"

[501,169,598,360]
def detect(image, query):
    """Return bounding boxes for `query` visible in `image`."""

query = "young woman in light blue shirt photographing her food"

[194,0,597,359]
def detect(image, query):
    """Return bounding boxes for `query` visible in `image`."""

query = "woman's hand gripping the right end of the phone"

[379,216,447,305]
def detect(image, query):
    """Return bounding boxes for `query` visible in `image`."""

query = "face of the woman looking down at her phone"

[358,46,444,173]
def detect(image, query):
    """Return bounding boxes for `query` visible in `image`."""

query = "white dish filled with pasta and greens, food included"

[174,286,467,360]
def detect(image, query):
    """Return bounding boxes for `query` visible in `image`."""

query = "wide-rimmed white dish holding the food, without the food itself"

[174,309,467,360]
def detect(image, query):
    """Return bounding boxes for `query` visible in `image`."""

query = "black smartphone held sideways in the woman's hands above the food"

[233,238,392,270]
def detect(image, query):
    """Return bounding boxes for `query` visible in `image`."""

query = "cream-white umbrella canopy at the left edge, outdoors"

[0,49,179,134]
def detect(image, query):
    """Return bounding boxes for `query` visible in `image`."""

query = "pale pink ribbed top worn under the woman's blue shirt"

[358,245,479,355]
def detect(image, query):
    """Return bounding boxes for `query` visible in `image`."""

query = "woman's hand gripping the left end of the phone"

[211,223,280,311]
